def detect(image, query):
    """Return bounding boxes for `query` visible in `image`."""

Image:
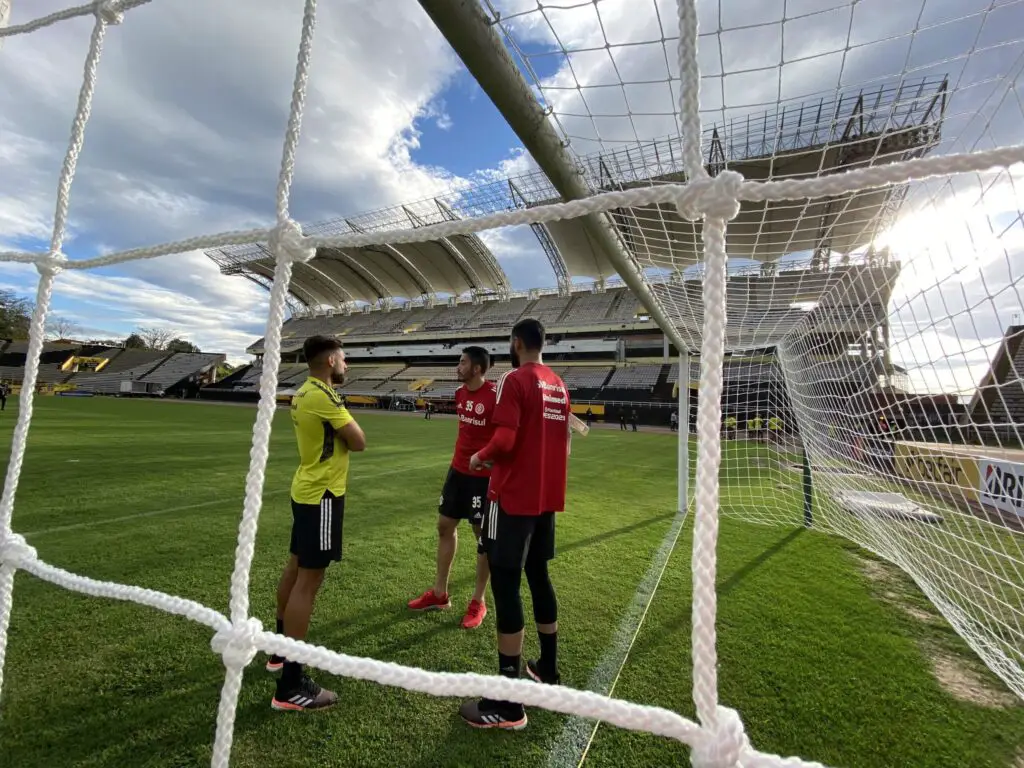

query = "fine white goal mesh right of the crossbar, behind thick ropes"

[487,0,1024,708]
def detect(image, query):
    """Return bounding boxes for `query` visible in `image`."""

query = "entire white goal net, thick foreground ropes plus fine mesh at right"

[0,0,1024,768]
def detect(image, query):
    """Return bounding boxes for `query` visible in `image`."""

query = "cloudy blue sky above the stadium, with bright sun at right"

[0,0,1024,397]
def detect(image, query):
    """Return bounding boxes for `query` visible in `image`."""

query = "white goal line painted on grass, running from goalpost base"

[548,495,689,768]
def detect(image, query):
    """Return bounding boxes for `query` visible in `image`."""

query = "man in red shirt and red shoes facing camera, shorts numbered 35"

[409,347,497,630]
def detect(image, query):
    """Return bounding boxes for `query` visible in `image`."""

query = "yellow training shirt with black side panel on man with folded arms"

[292,376,353,504]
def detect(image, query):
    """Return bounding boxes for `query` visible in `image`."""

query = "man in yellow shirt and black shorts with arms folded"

[266,336,367,711]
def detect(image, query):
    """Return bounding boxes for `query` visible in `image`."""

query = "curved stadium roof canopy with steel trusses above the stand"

[208,72,947,307]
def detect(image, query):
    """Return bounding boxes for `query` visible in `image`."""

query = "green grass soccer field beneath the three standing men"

[0,398,1024,768]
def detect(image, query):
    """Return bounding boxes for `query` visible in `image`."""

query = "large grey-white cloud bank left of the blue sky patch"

[0,0,528,353]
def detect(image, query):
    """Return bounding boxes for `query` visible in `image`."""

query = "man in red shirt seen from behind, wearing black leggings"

[460,318,570,730]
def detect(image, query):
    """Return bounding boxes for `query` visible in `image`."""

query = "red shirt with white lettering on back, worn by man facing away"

[487,362,569,515]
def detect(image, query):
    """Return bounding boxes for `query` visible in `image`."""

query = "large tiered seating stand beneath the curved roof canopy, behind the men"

[182,258,950,428]
